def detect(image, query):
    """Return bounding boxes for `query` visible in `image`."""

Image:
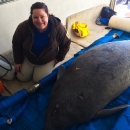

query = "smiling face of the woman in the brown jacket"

[32,9,48,32]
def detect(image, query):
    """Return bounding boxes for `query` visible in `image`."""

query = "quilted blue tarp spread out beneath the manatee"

[0,29,130,130]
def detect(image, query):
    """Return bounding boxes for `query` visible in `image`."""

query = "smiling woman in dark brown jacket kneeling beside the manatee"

[12,2,71,82]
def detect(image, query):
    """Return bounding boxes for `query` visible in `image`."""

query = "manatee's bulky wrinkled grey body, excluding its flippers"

[45,41,130,130]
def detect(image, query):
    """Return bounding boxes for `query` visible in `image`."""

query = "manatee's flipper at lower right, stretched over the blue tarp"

[93,104,130,119]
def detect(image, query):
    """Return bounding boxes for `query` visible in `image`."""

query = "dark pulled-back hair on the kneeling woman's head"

[30,2,49,15]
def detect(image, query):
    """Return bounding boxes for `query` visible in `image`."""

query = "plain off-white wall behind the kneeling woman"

[0,0,110,54]
